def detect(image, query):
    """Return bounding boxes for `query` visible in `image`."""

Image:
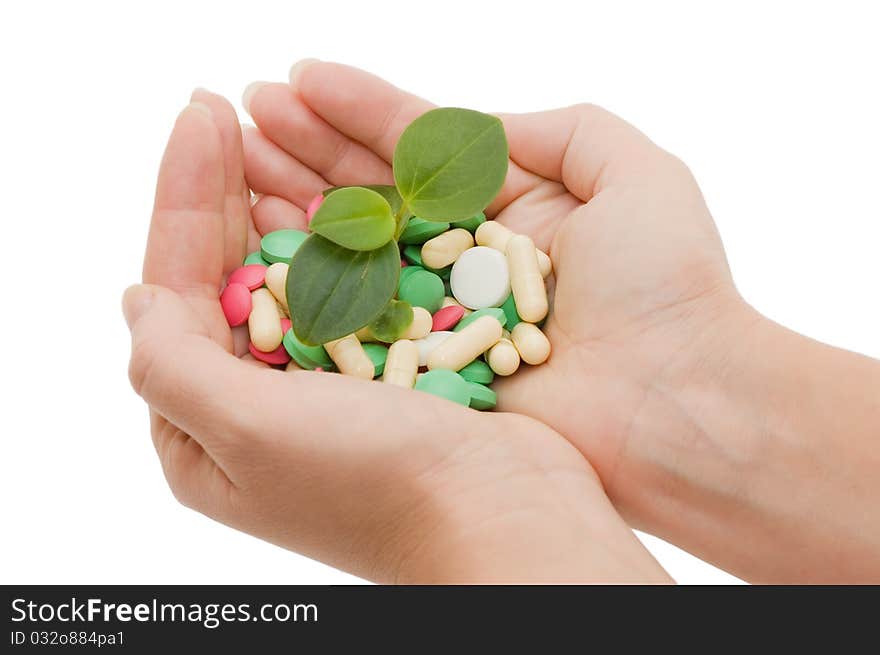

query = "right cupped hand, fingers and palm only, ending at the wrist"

[244,60,752,526]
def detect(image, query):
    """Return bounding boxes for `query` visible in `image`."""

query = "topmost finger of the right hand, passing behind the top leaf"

[290,59,542,217]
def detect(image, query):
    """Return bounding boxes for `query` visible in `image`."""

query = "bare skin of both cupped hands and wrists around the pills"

[126,60,880,582]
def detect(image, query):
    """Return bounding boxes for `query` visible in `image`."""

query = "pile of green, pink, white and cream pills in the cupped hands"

[220,196,551,410]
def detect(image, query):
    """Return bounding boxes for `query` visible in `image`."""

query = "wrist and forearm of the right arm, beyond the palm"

[631,303,880,583]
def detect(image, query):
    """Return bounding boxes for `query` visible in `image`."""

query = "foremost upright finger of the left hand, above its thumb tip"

[143,102,231,348]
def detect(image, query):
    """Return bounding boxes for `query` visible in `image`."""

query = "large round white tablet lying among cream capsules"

[449,246,510,309]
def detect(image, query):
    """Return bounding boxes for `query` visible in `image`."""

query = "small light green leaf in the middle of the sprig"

[309,187,396,250]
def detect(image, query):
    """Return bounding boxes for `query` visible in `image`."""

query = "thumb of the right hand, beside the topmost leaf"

[499,105,670,202]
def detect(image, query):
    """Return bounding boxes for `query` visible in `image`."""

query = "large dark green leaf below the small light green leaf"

[287,234,400,346]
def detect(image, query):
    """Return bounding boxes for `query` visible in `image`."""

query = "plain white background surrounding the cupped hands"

[0,0,880,584]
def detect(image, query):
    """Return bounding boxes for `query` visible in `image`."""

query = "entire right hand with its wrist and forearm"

[245,61,880,582]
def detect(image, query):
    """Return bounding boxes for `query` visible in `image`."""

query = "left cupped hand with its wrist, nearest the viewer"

[123,92,669,582]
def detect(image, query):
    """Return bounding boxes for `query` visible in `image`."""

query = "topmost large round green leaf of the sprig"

[394,108,507,221]
